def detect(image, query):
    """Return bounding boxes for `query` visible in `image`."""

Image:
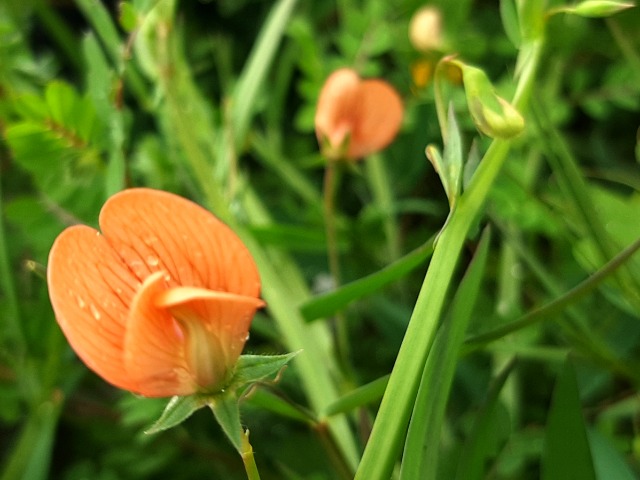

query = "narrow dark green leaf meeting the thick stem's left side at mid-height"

[300,237,434,321]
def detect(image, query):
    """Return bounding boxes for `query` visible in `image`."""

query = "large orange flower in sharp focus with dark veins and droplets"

[47,188,264,397]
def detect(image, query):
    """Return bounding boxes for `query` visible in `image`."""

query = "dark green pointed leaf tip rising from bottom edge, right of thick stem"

[541,359,596,480]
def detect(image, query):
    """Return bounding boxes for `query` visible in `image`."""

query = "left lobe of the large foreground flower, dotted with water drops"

[47,225,139,390]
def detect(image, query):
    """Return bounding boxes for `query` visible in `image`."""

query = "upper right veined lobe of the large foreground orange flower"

[100,188,260,297]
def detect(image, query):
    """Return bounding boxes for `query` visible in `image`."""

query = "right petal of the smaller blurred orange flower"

[347,80,404,158]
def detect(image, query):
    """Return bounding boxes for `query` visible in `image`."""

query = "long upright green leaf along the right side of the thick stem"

[400,230,491,480]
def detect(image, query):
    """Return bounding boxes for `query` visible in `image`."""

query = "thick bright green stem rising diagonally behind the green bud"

[356,37,542,480]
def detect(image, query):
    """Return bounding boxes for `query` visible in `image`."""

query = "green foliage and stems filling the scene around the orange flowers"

[0,0,640,480]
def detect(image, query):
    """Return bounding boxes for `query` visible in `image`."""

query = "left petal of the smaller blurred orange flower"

[315,68,361,151]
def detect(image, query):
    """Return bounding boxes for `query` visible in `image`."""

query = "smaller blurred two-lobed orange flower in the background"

[315,68,404,160]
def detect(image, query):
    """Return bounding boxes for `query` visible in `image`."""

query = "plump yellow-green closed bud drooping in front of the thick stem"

[455,61,524,138]
